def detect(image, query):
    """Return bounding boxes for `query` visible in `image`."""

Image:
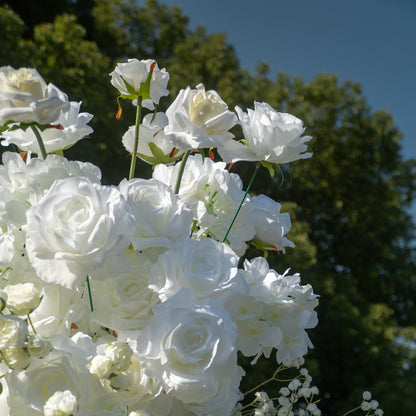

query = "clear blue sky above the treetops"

[161,0,416,164]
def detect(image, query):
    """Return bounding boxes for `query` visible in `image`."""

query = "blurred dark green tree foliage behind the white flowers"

[0,0,416,415]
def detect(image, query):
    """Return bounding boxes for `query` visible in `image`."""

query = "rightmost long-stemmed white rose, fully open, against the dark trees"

[218,102,312,164]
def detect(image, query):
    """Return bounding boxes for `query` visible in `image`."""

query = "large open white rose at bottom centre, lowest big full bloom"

[138,290,238,404]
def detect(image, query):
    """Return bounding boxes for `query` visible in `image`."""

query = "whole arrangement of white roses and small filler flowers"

[0,59,382,416]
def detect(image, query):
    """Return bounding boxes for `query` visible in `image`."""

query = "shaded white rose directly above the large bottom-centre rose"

[149,238,238,301]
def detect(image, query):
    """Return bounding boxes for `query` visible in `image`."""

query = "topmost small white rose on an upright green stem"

[110,58,169,110]
